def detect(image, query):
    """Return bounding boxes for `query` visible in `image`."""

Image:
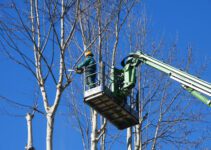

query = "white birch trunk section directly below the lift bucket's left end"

[91,110,97,150]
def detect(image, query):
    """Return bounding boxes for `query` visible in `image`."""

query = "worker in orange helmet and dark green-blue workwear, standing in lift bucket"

[76,50,96,89]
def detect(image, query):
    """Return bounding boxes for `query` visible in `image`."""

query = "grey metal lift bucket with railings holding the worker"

[84,63,139,130]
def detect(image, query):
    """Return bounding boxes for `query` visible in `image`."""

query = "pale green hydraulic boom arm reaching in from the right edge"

[122,51,211,107]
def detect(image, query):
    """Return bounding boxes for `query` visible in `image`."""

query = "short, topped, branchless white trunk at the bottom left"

[25,113,33,150]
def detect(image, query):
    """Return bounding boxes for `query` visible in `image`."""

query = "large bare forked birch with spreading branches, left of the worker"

[1,0,80,150]
